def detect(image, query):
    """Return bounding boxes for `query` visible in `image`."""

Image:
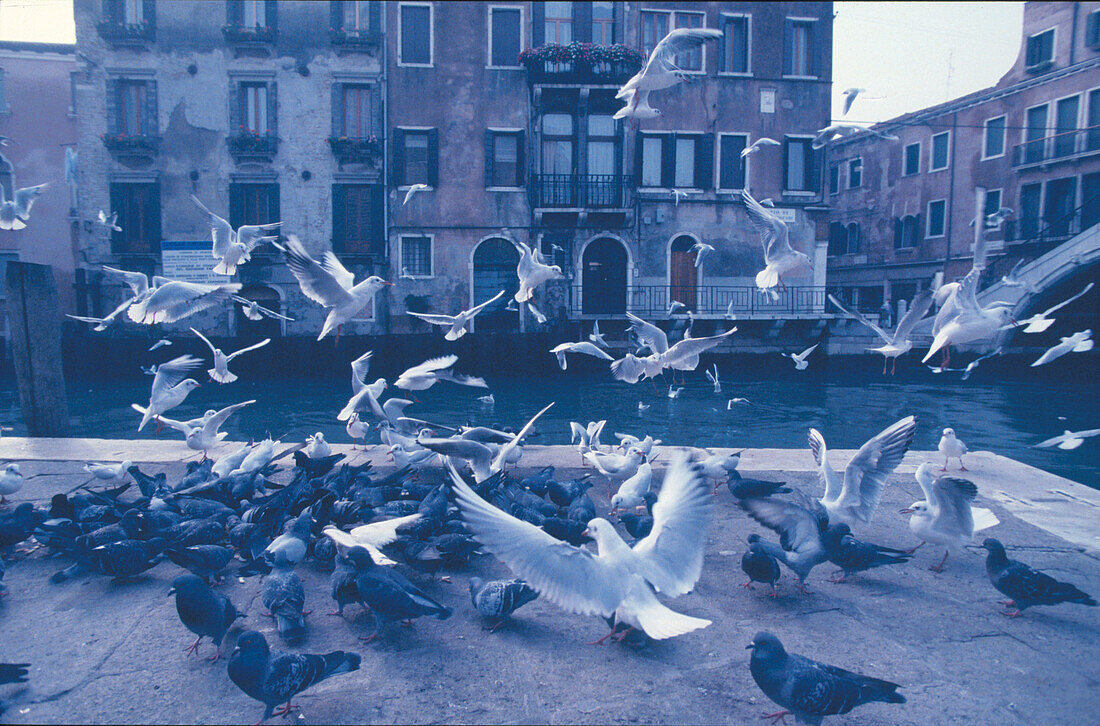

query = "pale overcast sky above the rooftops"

[0,0,1023,122]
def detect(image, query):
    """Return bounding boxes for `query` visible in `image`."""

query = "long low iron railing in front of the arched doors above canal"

[569,285,825,319]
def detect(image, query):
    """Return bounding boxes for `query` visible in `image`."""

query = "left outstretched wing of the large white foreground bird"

[450,468,628,617]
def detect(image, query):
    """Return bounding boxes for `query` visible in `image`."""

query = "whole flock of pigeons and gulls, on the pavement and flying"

[0,29,1097,724]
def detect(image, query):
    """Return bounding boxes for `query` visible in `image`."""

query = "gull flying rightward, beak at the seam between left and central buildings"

[275,234,393,340]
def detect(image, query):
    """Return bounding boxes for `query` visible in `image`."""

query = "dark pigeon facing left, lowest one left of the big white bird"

[229,630,362,723]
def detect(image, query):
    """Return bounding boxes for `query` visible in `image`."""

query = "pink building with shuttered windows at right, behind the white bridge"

[826,2,1100,312]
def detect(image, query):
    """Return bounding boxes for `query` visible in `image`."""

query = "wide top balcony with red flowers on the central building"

[519,43,646,86]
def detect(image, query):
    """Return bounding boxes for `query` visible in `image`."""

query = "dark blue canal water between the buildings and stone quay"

[0,363,1100,487]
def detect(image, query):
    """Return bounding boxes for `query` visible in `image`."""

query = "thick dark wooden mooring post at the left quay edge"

[4,262,69,437]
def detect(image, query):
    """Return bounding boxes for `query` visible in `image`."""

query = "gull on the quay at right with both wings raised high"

[809,416,916,525]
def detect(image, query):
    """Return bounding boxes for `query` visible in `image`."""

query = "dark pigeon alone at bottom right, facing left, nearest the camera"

[747,633,905,726]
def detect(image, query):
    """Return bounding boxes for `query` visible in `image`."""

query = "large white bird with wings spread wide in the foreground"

[451,458,714,644]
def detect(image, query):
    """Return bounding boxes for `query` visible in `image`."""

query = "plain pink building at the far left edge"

[0,41,78,338]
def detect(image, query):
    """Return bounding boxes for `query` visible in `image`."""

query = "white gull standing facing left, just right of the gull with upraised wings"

[901,462,1000,572]
